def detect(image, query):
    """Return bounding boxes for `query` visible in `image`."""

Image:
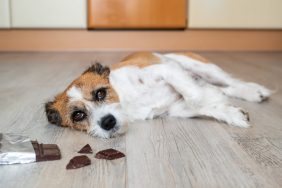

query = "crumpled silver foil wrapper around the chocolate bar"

[0,133,36,164]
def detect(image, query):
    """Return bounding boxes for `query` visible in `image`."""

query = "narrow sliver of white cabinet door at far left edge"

[0,0,10,28]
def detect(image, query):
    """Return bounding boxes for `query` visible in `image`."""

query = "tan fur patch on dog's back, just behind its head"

[111,52,160,69]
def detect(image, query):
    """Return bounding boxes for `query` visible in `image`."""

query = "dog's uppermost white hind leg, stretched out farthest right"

[162,54,271,102]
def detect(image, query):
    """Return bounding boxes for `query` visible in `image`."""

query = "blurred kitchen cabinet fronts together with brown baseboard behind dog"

[0,0,282,51]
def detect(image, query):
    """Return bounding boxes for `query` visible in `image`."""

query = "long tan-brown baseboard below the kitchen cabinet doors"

[0,29,282,51]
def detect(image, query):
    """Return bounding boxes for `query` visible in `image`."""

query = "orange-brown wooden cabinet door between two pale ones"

[88,0,186,29]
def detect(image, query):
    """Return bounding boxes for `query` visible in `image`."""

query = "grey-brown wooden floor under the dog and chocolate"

[0,52,282,188]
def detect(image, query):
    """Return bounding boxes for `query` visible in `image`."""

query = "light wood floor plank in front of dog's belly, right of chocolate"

[126,119,279,187]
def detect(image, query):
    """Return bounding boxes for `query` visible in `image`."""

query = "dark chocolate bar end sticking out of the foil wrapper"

[31,141,61,162]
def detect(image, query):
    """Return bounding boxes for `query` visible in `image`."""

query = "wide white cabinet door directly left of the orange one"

[11,0,87,28]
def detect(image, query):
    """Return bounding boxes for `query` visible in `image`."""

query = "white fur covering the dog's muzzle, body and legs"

[67,53,271,138]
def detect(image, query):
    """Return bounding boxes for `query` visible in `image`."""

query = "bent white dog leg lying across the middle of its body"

[148,62,226,109]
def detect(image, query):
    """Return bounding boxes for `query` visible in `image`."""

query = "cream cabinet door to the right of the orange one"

[188,0,282,29]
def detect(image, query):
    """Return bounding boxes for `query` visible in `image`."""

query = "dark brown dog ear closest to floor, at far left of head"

[45,101,62,126]
